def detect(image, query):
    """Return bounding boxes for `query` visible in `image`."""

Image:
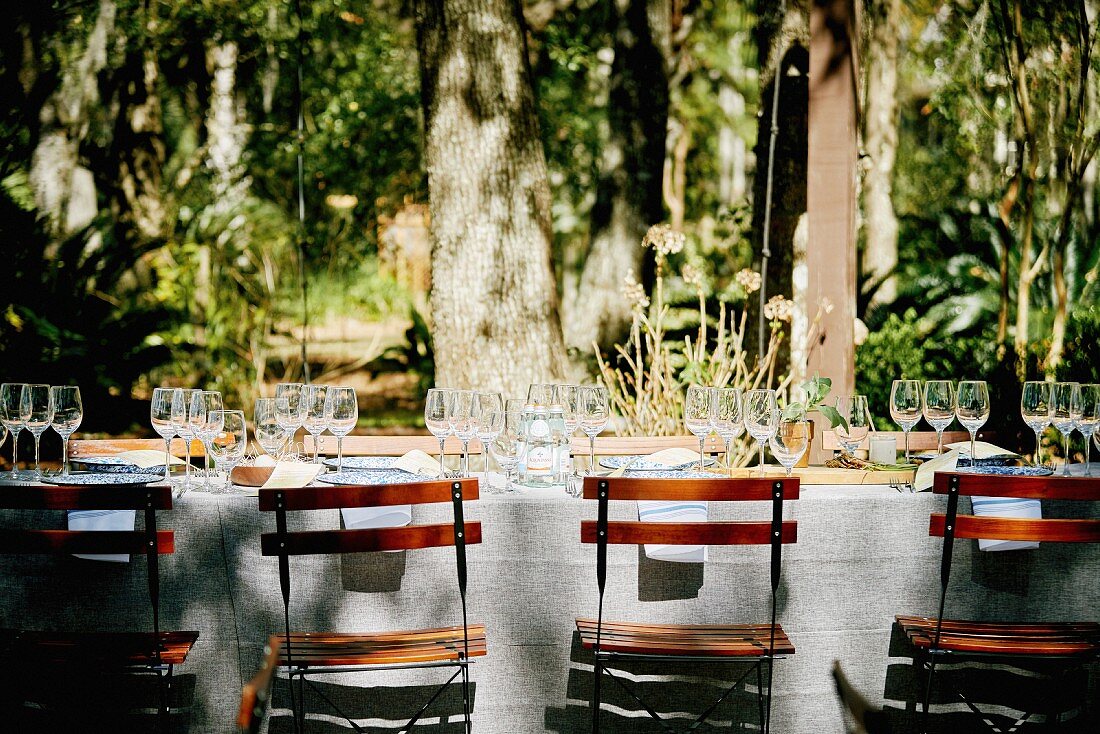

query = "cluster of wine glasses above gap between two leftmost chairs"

[149,387,231,494]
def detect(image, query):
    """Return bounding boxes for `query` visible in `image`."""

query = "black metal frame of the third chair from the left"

[592,480,787,734]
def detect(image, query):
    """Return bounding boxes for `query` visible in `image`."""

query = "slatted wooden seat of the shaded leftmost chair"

[12,631,199,668]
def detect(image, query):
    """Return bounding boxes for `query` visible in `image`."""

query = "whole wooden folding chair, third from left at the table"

[576,476,799,734]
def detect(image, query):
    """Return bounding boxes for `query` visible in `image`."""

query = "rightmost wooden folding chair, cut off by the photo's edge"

[897,473,1100,732]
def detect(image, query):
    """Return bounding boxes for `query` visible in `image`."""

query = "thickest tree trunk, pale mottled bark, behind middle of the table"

[416,0,565,396]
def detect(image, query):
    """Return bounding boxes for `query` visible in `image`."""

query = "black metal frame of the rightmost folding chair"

[914,474,1100,734]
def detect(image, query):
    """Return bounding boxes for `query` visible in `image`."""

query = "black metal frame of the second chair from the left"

[266,482,472,734]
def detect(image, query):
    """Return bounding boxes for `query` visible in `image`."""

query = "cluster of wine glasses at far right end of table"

[1020,382,1100,476]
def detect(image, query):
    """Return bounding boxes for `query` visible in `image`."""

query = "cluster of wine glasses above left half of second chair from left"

[260,382,359,471]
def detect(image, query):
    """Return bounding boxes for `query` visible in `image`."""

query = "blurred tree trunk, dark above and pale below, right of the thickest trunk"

[567,0,669,352]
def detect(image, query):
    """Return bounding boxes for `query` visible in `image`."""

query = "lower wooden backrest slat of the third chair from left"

[581,519,799,546]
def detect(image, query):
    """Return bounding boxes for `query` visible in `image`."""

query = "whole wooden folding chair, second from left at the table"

[260,479,486,733]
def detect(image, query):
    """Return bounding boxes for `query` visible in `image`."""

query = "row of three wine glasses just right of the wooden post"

[890,380,990,463]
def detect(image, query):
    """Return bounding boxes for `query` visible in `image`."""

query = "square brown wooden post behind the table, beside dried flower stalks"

[806,0,859,463]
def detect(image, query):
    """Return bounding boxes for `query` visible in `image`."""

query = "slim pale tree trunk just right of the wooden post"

[864,0,901,304]
